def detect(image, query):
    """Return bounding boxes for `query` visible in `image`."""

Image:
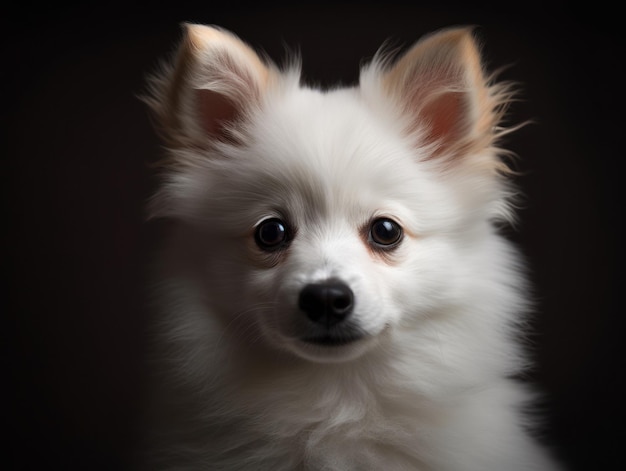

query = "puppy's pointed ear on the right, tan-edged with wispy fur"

[361,28,510,165]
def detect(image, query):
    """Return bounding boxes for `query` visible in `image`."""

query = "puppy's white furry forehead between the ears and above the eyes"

[234,89,420,216]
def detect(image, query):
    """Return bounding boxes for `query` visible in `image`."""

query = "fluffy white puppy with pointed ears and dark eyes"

[146,24,558,471]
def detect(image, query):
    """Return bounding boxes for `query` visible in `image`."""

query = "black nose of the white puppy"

[298,280,354,327]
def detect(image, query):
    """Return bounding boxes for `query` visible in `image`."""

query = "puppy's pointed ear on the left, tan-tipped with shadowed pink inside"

[146,24,271,147]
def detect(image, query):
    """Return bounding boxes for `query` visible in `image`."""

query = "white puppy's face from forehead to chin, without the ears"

[192,90,464,361]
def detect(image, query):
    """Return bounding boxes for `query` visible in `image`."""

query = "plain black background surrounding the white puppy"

[0,1,626,471]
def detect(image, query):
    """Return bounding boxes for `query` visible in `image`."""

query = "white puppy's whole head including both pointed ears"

[148,25,510,361]
